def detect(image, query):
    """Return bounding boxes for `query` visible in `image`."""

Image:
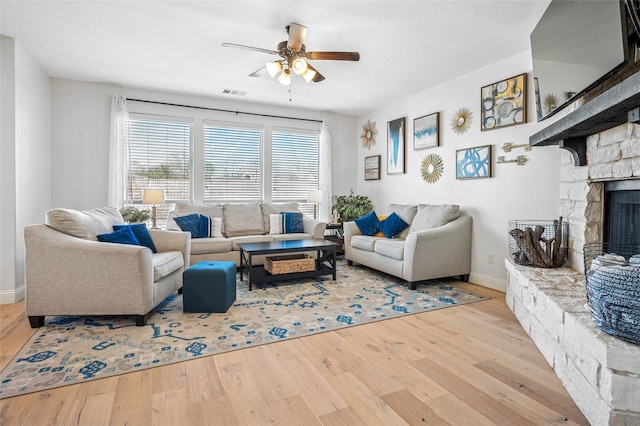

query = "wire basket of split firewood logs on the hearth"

[508,218,569,268]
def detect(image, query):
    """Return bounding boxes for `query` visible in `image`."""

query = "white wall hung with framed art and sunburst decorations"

[357,51,561,291]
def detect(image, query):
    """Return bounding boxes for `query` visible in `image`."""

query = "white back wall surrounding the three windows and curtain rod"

[51,78,357,209]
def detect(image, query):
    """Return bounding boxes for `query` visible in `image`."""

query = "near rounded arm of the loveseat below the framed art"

[403,215,472,281]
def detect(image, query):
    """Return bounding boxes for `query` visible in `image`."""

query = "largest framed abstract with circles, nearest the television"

[480,74,527,130]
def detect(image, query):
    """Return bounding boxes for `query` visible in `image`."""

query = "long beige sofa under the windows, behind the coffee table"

[166,202,327,265]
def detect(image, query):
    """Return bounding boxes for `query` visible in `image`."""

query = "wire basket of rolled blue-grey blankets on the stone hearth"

[584,243,640,345]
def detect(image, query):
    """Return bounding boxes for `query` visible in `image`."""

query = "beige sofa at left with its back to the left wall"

[24,207,191,328]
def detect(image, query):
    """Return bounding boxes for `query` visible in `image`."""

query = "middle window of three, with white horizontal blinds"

[204,124,263,202]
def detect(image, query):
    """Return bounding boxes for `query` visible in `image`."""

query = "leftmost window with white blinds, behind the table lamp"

[125,115,193,225]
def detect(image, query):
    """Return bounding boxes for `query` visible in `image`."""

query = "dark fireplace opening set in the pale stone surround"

[603,179,640,252]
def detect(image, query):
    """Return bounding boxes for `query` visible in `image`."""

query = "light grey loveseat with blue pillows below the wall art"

[344,204,472,289]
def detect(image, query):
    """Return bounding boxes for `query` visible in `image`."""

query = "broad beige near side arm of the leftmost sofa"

[24,225,153,315]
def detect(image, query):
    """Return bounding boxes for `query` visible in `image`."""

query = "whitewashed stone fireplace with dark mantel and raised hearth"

[505,73,640,425]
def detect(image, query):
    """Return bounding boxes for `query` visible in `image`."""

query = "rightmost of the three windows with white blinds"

[271,128,320,215]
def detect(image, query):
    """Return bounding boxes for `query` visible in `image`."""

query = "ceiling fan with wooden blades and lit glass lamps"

[222,22,360,86]
